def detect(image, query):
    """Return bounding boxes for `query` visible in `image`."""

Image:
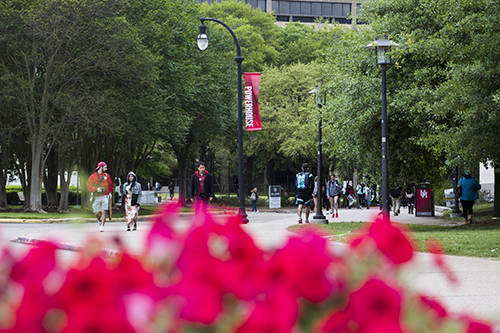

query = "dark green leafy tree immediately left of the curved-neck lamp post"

[128,0,237,195]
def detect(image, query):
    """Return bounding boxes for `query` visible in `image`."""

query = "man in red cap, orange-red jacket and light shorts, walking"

[87,162,113,232]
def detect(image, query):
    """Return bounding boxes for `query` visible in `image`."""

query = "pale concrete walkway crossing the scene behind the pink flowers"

[0,209,500,323]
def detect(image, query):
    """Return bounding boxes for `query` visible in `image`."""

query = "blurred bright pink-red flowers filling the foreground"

[0,201,492,333]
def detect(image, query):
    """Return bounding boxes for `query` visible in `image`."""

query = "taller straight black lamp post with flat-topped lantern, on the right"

[366,35,401,218]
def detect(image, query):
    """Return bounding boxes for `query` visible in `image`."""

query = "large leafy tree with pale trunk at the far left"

[0,0,156,212]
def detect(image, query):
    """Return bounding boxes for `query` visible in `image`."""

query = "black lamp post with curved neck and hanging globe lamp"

[197,17,248,223]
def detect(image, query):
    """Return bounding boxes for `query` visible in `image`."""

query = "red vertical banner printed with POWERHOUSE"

[245,73,262,131]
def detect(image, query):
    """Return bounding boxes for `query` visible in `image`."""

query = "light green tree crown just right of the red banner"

[245,63,321,176]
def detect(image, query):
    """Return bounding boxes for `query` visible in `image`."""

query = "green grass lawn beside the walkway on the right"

[288,204,500,260]
